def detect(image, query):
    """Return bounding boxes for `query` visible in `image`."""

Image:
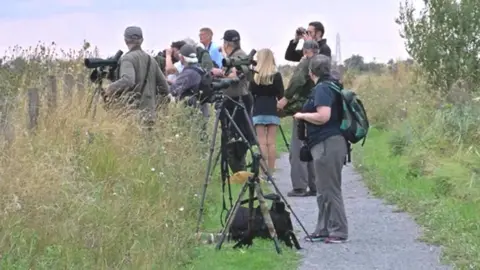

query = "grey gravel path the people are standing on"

[275,154,453,270]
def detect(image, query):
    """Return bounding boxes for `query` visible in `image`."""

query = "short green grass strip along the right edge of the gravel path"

[354,129,480,269]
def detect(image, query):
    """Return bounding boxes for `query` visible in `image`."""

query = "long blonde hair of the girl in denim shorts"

[253,49,277,85]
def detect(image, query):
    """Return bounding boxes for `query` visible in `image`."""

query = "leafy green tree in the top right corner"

[396,0,480,91]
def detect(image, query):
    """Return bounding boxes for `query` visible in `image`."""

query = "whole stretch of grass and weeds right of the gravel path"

[347,66,480,269]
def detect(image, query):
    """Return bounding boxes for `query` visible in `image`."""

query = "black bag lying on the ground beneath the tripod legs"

[229,194,301,249]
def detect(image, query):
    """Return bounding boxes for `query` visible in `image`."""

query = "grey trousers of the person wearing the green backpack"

[311,136,348,238]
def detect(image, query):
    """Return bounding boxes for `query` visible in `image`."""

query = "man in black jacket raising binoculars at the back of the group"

[285,22,332,62]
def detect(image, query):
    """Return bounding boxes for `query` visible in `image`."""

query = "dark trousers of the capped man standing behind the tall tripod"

[221,95,255,173]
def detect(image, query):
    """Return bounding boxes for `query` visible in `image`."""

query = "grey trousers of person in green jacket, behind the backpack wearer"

[289,119,317,190]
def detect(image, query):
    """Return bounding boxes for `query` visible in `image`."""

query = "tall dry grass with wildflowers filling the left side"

[0,43,210,269]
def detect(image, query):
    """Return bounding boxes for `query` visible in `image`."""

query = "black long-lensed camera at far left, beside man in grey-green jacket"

[84,50,123,83]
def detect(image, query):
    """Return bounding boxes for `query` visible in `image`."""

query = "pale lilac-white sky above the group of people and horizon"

[0,0,421,63]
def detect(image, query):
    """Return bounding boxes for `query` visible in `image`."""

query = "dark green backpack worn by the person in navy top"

[328,82,370,146]
